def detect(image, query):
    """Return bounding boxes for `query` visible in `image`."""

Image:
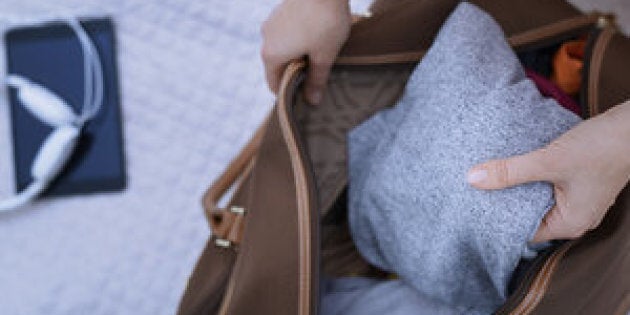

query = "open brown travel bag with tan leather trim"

[179,0,630,315]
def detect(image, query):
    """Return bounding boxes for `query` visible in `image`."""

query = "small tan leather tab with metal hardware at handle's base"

[210,206,246,248]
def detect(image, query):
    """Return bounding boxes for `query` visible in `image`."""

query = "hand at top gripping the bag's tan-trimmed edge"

[262,0,351,104]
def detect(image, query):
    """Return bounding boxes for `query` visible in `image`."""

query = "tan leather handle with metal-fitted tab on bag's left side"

[203,117,269,247]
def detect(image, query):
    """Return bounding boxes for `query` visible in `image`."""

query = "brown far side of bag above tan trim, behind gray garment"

[339,0,583,57]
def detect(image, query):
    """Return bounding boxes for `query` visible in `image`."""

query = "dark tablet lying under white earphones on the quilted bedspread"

[4,18,126,195]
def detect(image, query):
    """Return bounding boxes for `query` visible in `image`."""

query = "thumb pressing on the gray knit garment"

[467,149,551,189]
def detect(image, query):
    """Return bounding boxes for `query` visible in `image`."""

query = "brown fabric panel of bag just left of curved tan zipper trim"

[218,107,301,315]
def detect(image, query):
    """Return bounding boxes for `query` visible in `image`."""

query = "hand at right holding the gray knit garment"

[468,101,630,242]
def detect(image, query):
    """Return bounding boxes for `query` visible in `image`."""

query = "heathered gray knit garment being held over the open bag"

[348,3,580,313]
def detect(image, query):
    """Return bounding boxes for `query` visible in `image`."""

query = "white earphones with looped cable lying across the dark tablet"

[0,18,104,212]
